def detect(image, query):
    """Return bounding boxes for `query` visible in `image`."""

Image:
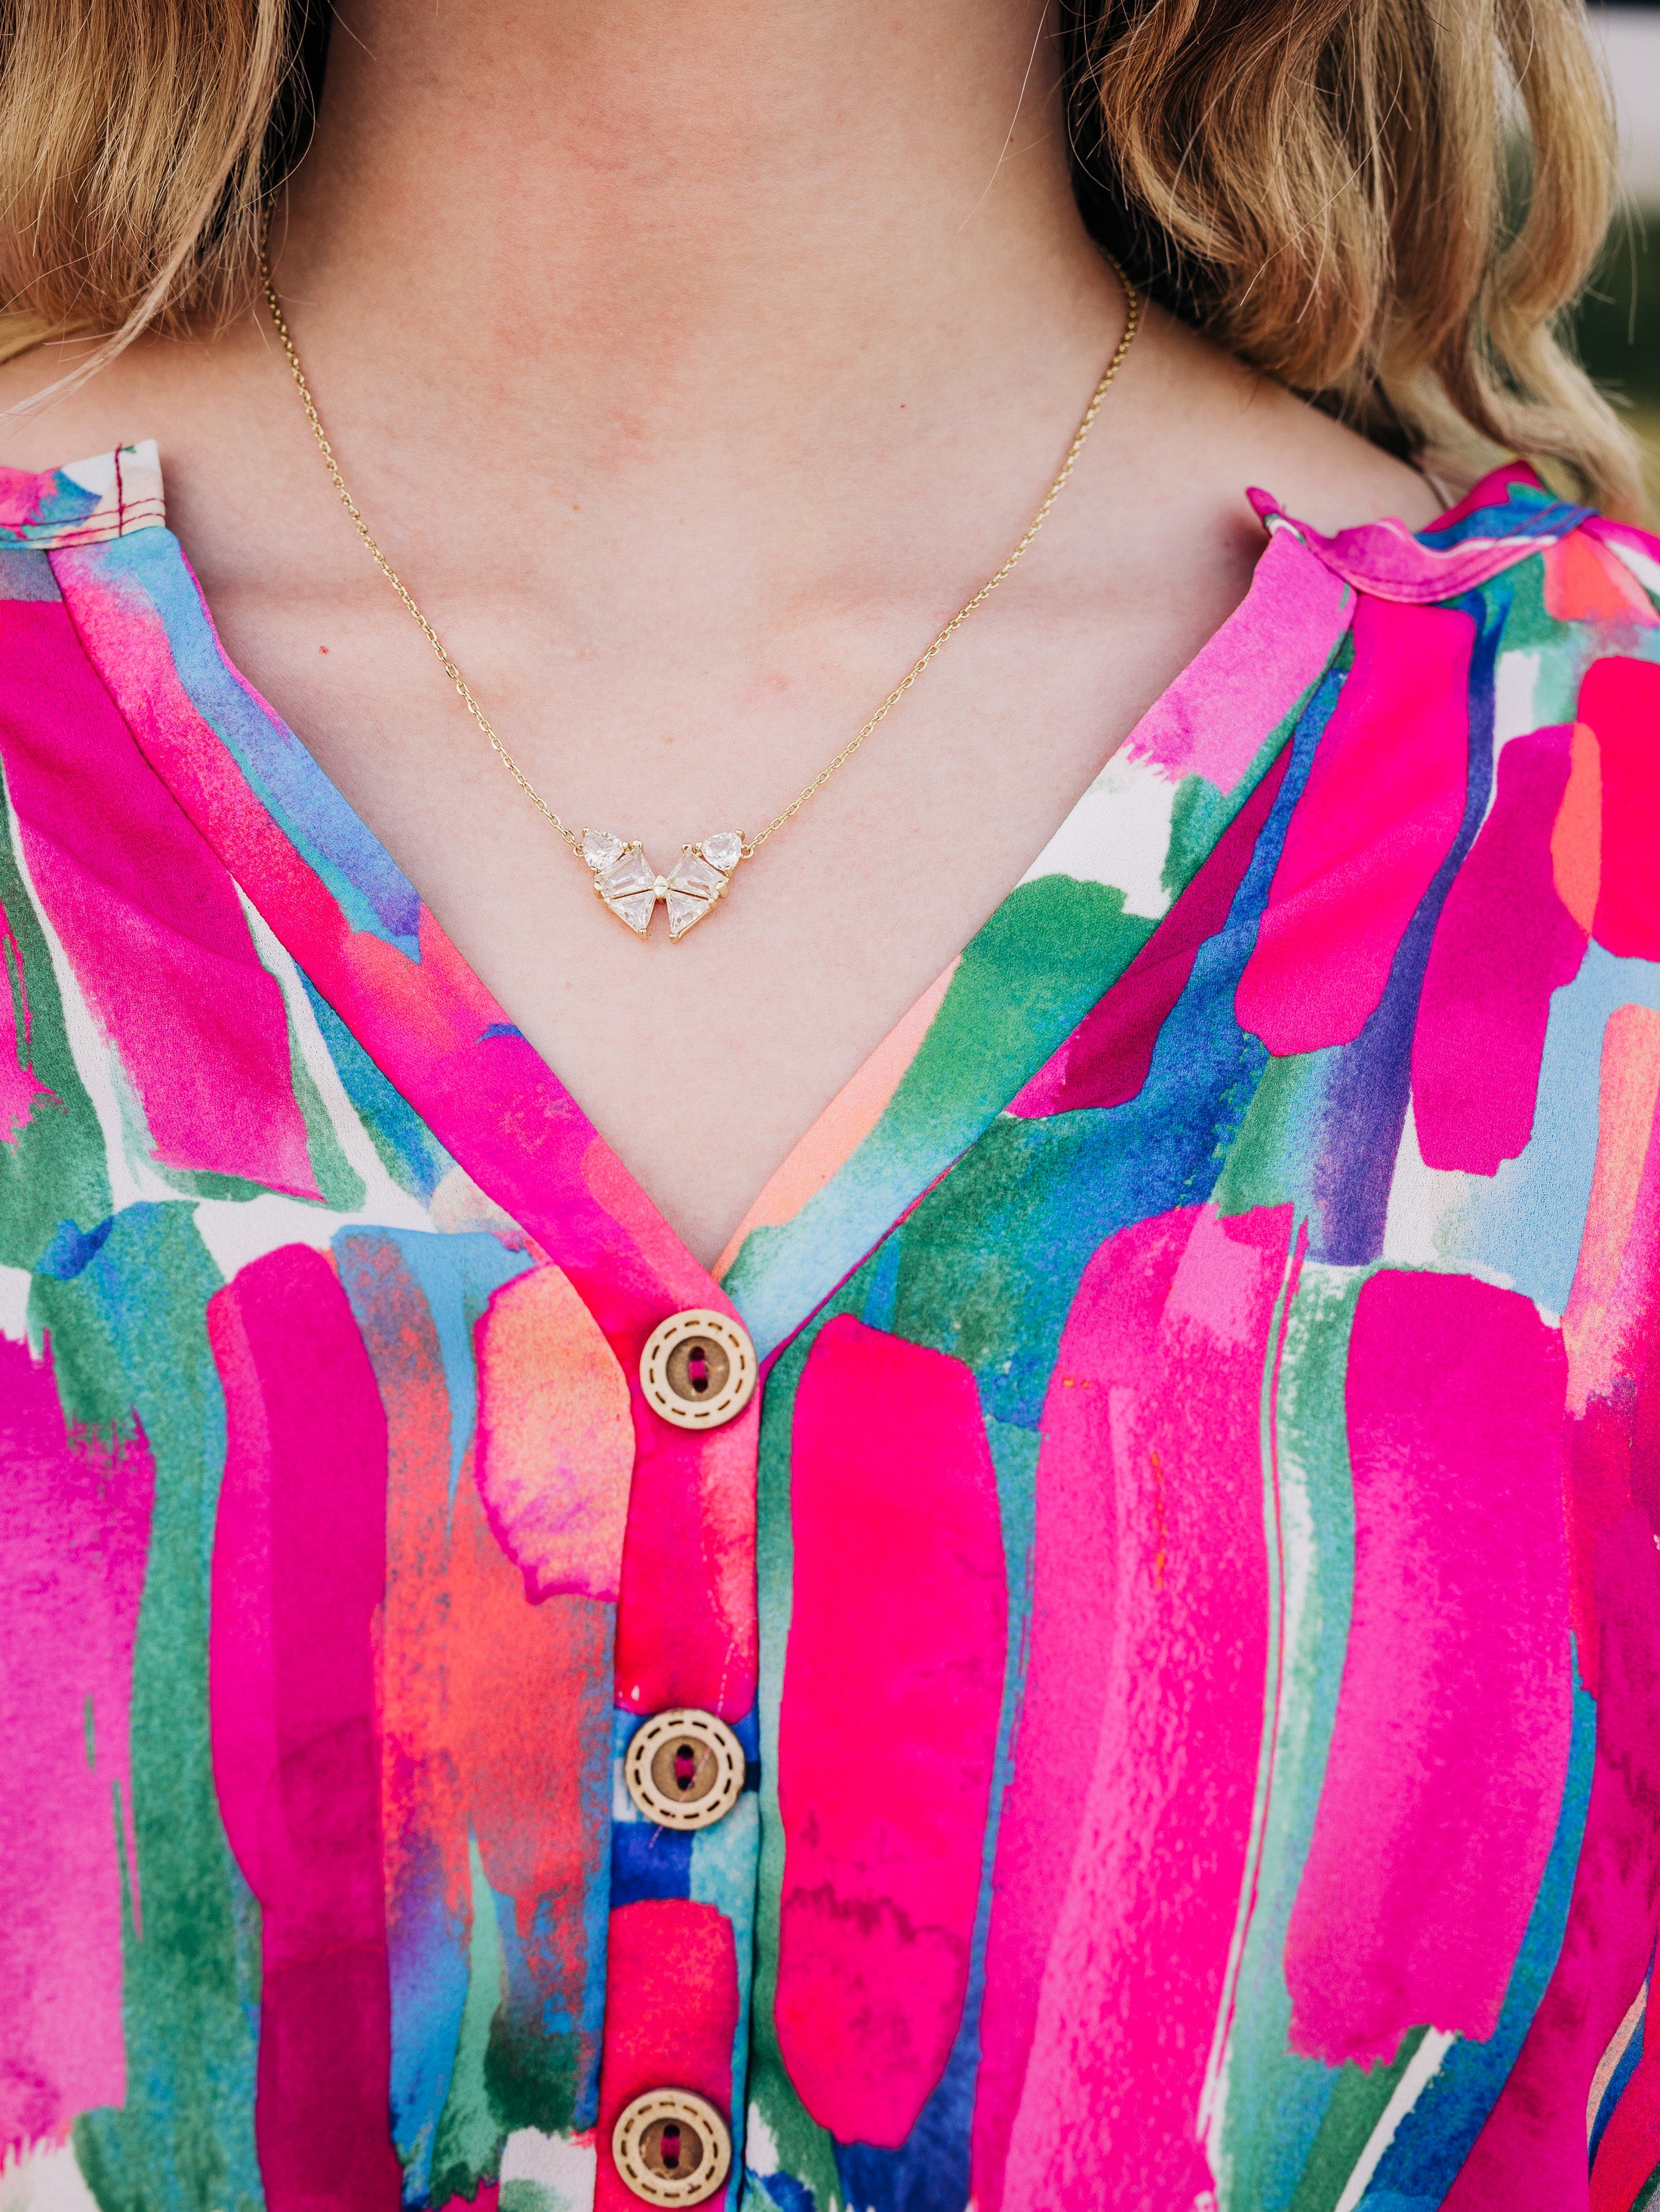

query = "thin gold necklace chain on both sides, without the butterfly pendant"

[259,208,1141,860]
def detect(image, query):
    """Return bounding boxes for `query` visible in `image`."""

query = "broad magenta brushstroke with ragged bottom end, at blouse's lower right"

[1286,1269,1572,2066]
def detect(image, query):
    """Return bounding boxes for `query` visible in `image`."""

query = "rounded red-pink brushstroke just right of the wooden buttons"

[773,1314,1008,2146]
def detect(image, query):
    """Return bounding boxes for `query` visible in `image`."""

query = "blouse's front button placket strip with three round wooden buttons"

[595,1292,761,2212]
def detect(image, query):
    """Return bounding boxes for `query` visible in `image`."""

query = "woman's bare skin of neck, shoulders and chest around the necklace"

[0,0,1439,1261]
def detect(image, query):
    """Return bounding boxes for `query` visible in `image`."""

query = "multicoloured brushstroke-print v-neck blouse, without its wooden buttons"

[0,447,1660,2212]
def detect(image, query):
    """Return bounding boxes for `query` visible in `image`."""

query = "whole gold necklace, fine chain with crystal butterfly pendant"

[259,219,1141,940]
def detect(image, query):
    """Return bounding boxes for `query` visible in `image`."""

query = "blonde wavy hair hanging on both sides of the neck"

[0,0,1638,513]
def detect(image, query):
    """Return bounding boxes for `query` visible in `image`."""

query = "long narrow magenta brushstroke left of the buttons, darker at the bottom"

[208,1245,402,2212]
